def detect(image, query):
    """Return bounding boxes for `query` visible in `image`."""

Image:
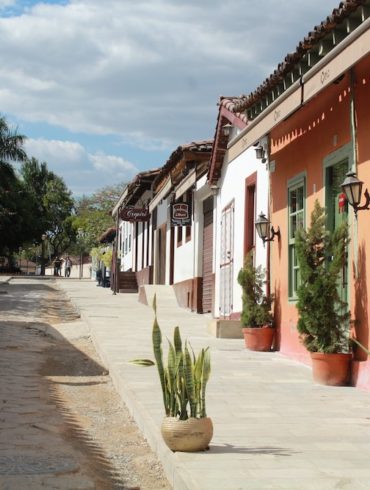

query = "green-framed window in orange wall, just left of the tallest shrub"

[288,178,306,299]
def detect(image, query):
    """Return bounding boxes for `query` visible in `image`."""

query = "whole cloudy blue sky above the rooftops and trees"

[0,0,339,196]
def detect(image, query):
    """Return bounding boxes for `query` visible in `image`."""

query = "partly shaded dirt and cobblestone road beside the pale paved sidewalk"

[0,278,171,490]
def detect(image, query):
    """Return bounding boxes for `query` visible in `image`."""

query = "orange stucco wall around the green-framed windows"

[270,56,370,388]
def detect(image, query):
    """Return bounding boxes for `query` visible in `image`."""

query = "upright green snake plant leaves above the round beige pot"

[148,297,211,420]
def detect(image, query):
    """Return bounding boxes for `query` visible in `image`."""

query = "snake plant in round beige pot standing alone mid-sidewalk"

[132,296,213,452]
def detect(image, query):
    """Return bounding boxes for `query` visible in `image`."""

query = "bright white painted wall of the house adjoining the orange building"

[214,147,269,317]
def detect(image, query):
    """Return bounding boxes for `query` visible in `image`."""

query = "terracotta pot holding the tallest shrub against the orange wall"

[311,352,352,386]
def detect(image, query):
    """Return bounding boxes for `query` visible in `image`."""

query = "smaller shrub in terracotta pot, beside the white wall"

[238,253,274,351]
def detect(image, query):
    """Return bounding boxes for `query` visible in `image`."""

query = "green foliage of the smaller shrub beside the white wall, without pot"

[238,253,273,328]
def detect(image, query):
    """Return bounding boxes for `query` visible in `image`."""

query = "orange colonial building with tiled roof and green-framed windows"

[229,0,370,388]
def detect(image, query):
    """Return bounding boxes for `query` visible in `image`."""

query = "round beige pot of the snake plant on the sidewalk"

[161,417,213,452]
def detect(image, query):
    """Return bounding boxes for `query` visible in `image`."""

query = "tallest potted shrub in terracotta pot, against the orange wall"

[295,200,352,386]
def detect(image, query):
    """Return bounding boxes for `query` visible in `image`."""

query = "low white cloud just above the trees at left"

[25,139,139,194]
